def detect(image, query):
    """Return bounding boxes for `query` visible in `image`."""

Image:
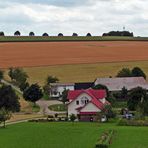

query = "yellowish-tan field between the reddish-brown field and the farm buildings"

[7,61,148,85]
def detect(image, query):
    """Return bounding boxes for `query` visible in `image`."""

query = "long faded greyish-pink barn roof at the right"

[94,77,148,92]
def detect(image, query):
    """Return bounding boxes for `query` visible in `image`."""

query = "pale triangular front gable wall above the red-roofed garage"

[81,102,101,112]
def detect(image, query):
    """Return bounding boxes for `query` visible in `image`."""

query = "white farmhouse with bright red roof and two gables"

[67,89,110,121]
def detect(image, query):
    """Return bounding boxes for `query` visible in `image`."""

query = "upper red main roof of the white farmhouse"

[67,89,106,100]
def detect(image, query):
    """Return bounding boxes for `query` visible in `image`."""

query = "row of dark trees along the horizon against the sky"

[0,30,134,37]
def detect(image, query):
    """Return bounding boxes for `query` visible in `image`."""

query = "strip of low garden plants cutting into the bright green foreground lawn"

[96,130,115,148]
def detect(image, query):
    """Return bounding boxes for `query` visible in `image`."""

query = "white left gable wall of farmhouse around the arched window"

[68,93,91,115]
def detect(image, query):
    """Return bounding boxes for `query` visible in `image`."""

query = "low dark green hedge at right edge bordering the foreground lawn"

[118,119,148,126]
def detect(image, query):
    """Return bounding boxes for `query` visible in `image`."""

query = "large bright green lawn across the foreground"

[0,122,148,148]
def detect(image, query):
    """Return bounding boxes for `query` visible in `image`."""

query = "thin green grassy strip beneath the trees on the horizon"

[0,36,148,42]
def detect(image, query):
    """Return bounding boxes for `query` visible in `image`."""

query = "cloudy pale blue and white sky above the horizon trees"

[0,0,148,36]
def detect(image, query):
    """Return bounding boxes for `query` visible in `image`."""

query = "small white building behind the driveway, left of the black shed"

[50,83,75,98]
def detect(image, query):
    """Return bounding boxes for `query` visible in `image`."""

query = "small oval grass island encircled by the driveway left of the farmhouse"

[48,104,67,111]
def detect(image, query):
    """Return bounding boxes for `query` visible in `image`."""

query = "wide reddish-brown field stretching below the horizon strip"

[0,41,148,68]
